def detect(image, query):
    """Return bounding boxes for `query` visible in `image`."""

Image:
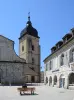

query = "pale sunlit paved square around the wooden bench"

[0,86,74,100]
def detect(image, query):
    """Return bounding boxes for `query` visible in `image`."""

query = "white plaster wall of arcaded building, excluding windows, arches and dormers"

[44,37,74,88]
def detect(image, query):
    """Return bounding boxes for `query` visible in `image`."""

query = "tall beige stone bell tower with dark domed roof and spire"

[19,16,40,82]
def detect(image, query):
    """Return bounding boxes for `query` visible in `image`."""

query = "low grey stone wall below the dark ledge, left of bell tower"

[0,62,26,84]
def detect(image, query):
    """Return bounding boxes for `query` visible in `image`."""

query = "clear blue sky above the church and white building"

[0,0,74,70]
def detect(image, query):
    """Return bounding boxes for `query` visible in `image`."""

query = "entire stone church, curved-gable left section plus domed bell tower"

[0,16,40,85]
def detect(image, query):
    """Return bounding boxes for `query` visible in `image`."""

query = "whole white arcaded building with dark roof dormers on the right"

[44,28,74,88]
